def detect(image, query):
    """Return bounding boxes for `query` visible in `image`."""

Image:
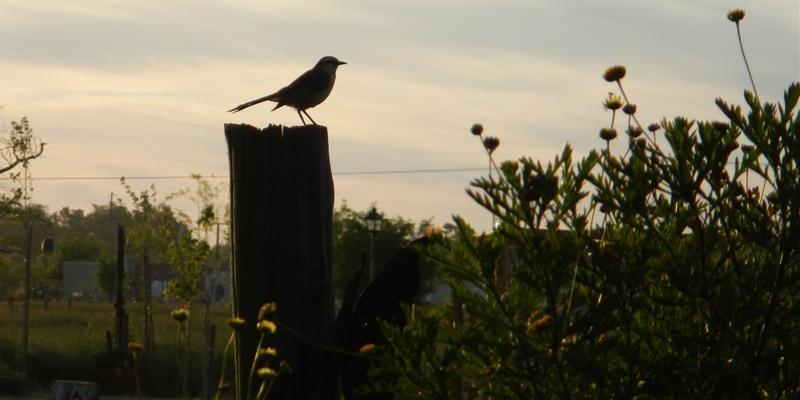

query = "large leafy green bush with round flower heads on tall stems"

[368,10,800,399]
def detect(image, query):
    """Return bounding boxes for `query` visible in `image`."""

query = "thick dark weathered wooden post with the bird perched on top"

[225,124,339,400]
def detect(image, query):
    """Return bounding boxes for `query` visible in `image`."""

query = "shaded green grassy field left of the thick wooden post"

[0,301,230,396]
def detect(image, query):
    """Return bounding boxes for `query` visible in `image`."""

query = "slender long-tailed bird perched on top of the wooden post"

[228,56,347,125]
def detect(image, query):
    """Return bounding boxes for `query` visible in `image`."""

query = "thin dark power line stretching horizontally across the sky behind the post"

[0,167,486,181]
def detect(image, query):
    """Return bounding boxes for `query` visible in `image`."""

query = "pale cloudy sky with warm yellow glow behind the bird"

[0,0,800,230]
